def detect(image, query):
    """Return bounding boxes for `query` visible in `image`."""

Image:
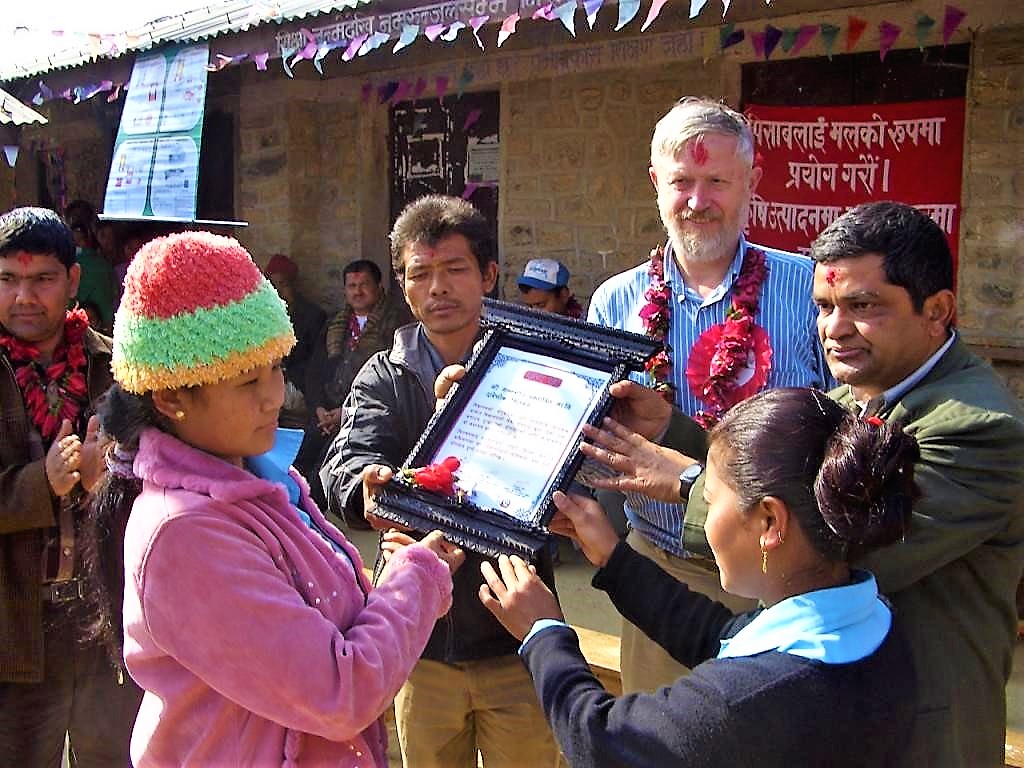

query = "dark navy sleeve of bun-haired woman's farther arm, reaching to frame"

[594,542,750,668]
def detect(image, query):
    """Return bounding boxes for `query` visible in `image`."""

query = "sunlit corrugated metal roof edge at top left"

[0,0,373,80]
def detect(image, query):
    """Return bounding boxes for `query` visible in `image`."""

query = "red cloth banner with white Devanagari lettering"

[746,98,964,258]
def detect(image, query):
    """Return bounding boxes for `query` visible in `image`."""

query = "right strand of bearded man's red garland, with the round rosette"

[686,246,772,429]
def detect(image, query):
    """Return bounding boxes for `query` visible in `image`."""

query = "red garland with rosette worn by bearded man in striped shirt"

[640,246,772,429]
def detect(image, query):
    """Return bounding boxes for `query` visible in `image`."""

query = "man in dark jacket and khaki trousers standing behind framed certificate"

[321,196,558,768]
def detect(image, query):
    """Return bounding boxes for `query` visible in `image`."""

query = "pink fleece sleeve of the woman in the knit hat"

[135,514,452,741]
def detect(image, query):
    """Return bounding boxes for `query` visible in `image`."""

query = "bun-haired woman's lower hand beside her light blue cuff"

[480,555,564,640]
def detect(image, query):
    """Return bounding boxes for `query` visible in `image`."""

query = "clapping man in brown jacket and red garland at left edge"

[0,208,141,768]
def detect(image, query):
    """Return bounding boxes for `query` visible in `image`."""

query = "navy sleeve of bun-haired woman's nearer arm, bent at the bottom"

[523,626,735,768]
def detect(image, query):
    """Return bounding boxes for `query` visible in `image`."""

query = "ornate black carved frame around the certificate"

[375,299,663,558]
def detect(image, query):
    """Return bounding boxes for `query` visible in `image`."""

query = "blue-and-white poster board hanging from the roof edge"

[103,44,210,221]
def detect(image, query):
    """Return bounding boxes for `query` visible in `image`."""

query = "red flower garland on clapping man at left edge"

[0,309,89,443]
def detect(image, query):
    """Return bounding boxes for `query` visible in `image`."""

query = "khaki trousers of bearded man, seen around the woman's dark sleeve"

[618,530,757,693]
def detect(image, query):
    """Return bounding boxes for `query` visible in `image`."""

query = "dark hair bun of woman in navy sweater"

[814,414,921,558]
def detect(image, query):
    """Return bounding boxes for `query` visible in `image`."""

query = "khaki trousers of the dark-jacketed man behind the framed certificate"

[394,654,558,768]
